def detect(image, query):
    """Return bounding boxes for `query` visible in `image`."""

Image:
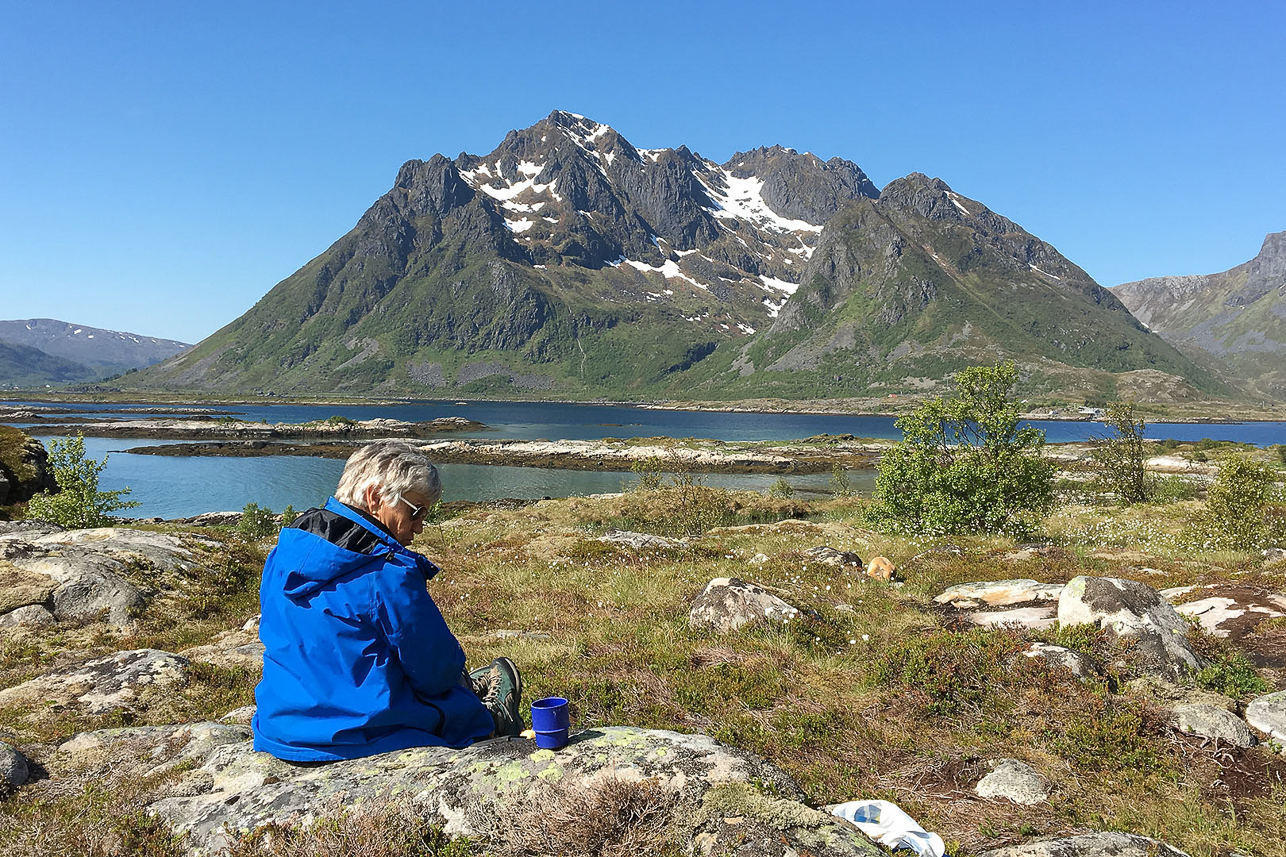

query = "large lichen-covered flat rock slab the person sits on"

[149,727,881,857]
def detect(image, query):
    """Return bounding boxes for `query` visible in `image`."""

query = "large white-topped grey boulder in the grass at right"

[1058,576,1209,682]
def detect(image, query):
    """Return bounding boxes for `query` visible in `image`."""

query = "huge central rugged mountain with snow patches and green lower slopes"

[131,111,1226,399]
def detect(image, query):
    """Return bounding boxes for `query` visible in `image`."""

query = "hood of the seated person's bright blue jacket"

[273,497,439,598]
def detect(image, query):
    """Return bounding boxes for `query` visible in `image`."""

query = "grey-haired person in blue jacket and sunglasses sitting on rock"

[253,441,522,762]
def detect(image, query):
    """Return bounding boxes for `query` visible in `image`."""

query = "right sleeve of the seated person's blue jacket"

[373,561,464,697]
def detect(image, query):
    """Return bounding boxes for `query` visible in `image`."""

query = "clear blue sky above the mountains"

[0,0,1286,341]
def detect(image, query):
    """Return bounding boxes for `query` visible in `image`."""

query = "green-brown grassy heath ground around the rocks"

[0,463,1286,857]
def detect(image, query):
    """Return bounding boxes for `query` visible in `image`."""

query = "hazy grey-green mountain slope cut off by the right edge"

[1112,232,1286,400]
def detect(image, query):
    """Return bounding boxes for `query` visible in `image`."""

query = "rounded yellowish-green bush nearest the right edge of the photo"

[1196,456,1277,551]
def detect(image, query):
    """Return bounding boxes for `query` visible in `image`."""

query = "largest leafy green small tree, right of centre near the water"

[869,363,1055,534]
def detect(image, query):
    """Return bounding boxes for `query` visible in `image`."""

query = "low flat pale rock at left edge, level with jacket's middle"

[0,649,190,714]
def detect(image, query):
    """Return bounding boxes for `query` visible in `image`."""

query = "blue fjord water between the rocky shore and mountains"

[17,401,1286,517]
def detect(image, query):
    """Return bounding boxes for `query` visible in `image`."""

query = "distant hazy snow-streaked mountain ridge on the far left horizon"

[0,318,192,381]
